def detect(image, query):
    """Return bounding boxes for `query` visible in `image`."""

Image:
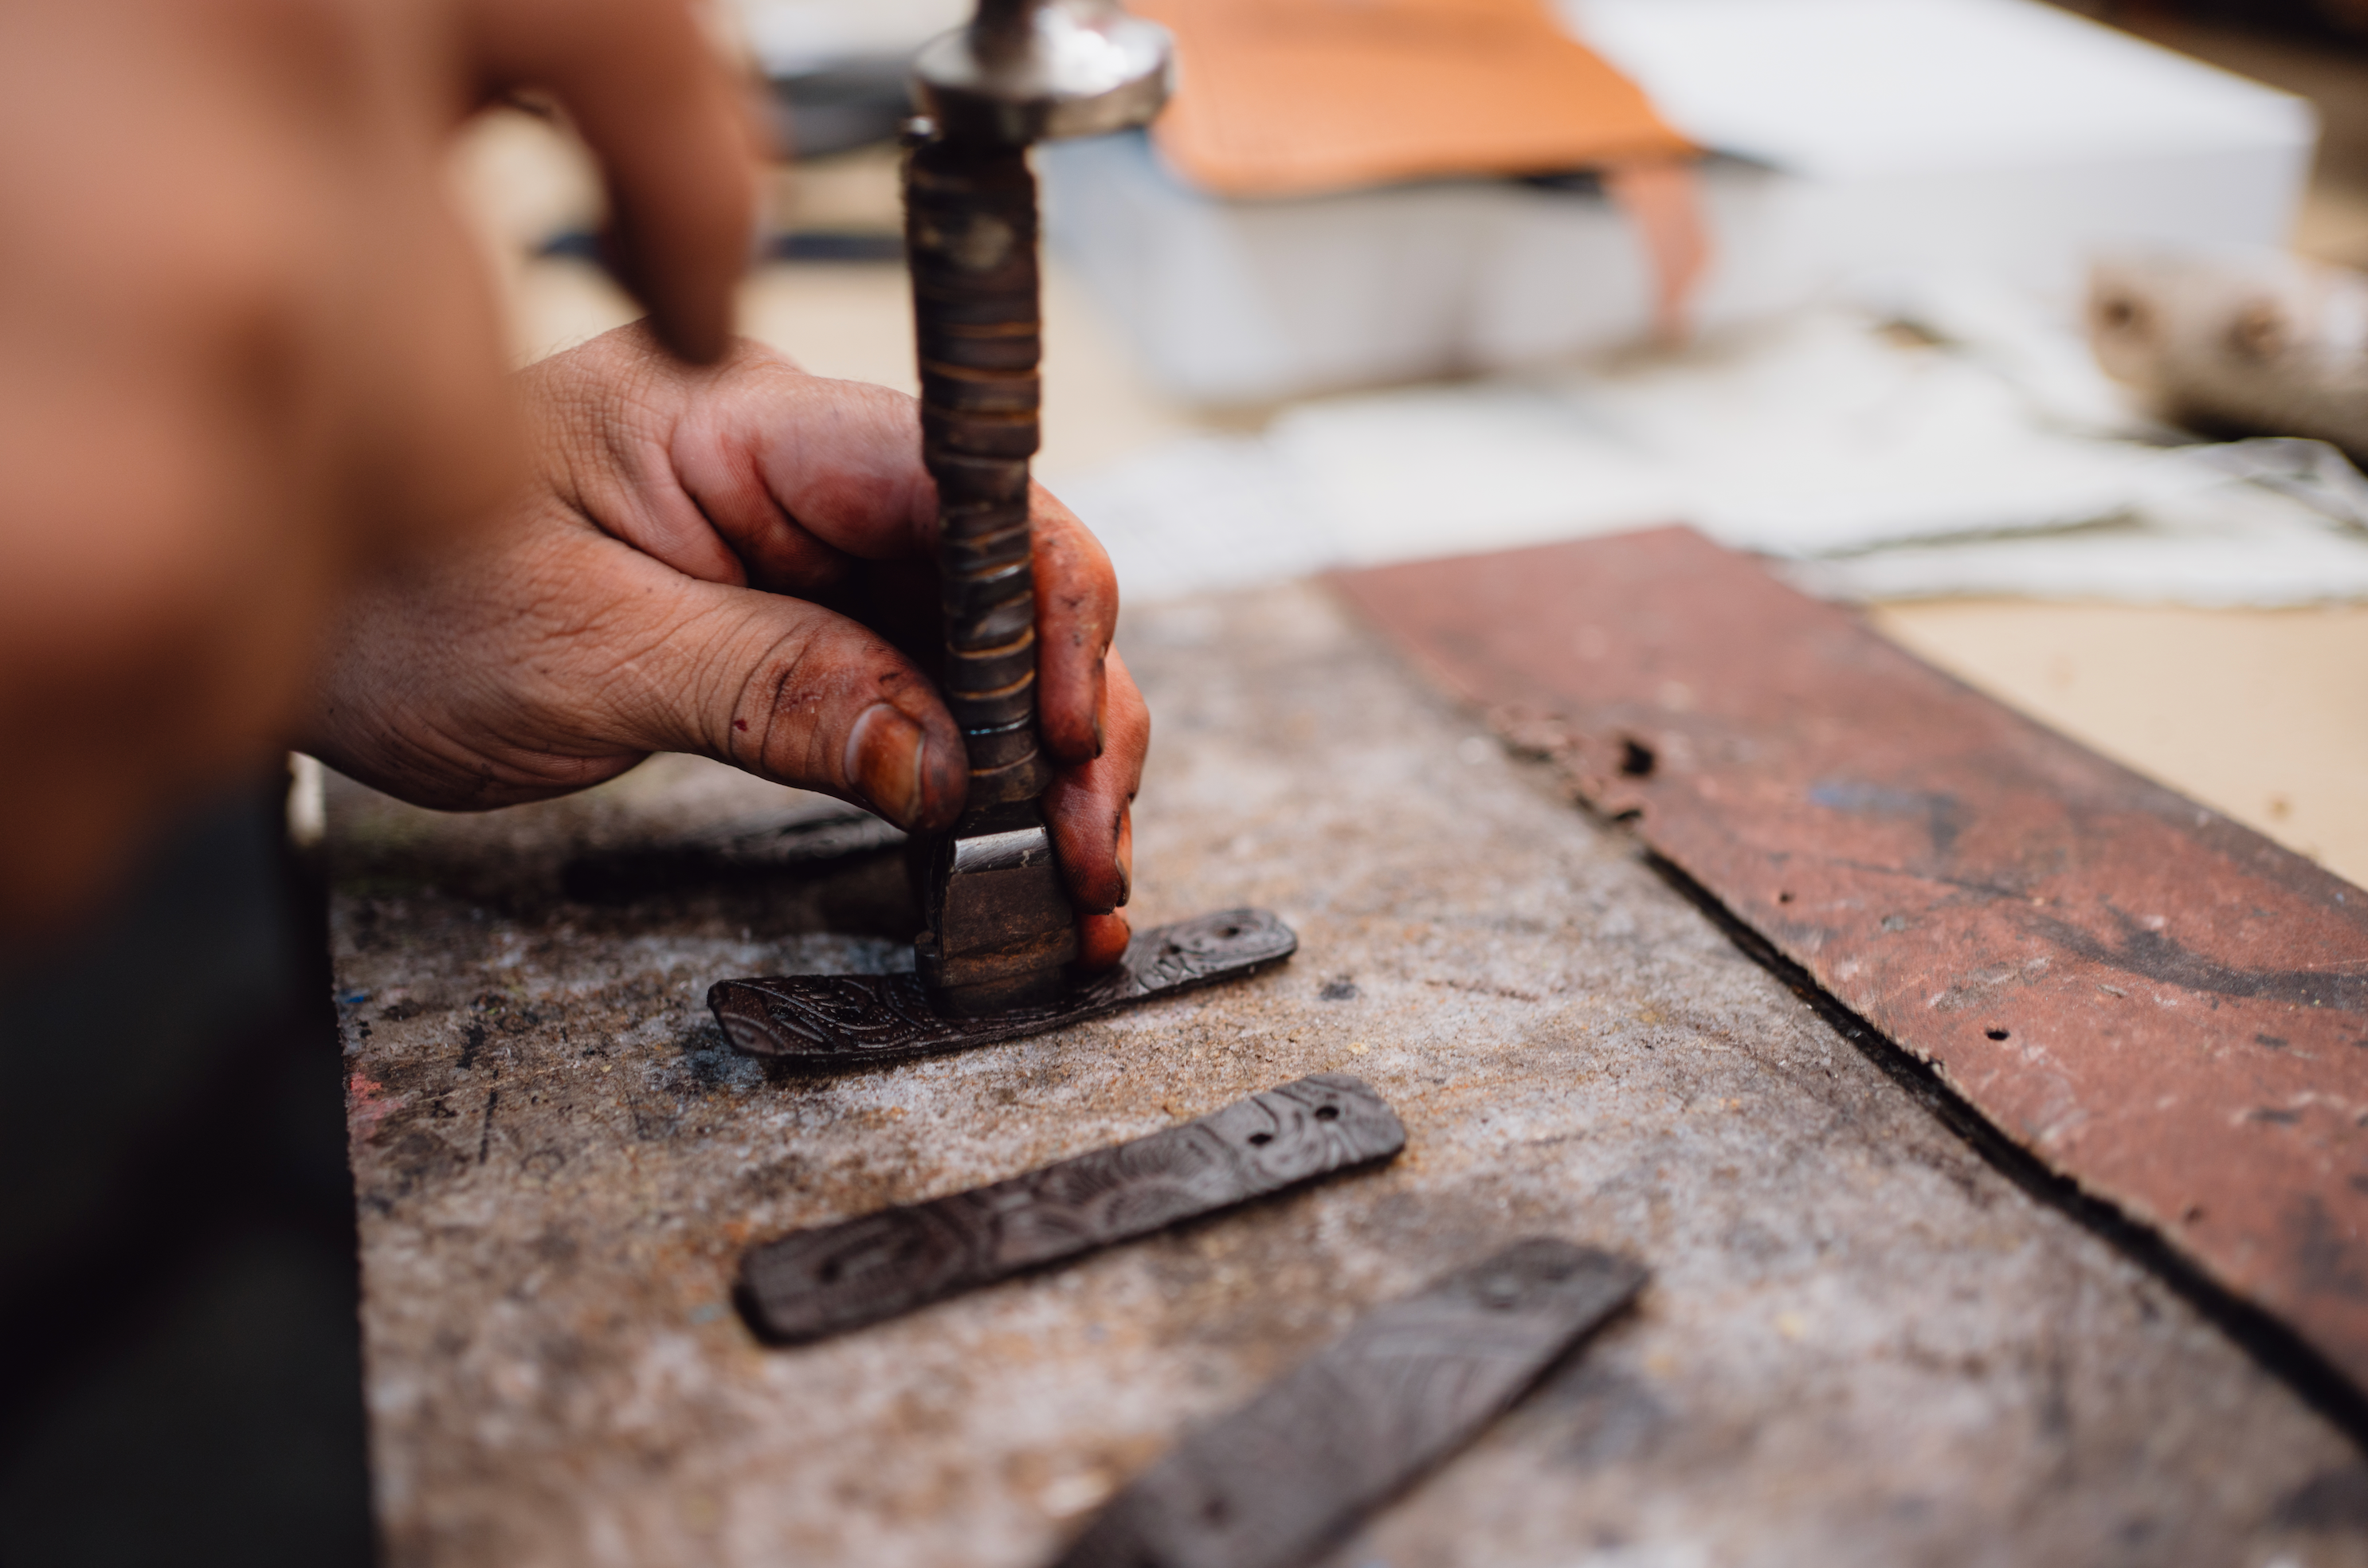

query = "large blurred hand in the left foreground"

[0,0,755,935]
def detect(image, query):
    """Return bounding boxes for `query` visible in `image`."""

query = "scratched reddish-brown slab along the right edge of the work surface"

[1338,528,2368,1386]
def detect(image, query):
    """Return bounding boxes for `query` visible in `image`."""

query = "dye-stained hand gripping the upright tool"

[303,327,1151,969]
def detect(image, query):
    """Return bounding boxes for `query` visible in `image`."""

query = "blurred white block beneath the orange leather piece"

[1040,0,2316,402]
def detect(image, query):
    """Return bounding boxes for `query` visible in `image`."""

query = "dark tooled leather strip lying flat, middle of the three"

[739,1073,1406,1343]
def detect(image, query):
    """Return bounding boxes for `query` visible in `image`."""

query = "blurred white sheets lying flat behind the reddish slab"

[1049,284,2368,604]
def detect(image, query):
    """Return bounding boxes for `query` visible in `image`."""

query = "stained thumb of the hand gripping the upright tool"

[604,562,971,831]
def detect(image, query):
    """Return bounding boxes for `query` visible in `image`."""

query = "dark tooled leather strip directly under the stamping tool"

[708,910,1300,1071]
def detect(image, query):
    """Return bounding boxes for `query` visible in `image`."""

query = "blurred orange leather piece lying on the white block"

[1132,0,1698,197]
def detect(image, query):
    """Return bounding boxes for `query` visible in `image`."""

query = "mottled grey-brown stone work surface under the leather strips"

[329,587,2368,1568]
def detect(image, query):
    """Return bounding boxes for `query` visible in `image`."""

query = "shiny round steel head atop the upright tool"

[912,0,1174,144]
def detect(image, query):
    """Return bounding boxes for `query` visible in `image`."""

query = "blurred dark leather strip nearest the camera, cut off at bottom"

[1057,1241,1646,1568]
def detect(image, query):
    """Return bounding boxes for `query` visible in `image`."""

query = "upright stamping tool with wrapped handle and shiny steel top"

[904,0,1170,1016]
